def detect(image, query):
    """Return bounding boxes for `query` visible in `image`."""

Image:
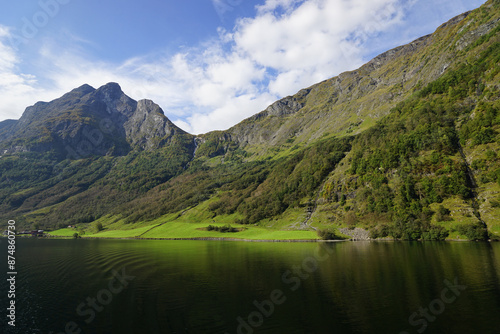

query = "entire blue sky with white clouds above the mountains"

[0,0,485,134]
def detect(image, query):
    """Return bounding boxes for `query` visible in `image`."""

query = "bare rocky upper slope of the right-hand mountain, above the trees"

[216,12,496,155]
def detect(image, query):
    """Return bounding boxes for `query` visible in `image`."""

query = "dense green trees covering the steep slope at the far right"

[316,12,500,239]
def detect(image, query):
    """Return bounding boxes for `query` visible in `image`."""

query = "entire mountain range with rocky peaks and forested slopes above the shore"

[0,0,500,239]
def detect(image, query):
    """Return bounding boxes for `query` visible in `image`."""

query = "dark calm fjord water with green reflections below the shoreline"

[0,239,500,334]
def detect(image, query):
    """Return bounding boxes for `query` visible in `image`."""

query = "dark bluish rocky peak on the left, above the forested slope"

[0,83,189,159]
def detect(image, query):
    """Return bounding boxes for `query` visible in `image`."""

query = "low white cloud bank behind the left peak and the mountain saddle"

[21,42,276,134]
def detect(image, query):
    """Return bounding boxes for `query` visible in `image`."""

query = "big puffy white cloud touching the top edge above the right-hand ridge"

[234,0,404,95]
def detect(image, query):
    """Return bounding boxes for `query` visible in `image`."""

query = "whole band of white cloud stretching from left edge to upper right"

[0,0,414,133]
